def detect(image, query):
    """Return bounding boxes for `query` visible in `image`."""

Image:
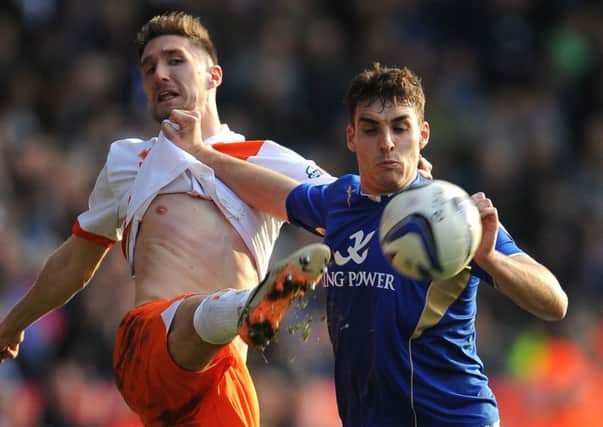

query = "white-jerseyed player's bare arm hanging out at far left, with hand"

[0,236,108,363]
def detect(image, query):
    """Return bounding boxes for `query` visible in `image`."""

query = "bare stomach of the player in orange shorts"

[134,193,258,305]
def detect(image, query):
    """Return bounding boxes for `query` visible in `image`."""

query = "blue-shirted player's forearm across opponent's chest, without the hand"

[193,149,298,220]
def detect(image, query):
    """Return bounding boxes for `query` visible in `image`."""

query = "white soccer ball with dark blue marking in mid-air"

[379,180,482,280]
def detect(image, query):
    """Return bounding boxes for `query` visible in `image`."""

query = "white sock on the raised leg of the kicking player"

[193,289,251,344]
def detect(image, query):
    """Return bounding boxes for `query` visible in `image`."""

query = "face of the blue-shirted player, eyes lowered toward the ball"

[346,100,429,194]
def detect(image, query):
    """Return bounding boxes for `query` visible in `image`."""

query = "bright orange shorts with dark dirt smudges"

[113,296,260,427]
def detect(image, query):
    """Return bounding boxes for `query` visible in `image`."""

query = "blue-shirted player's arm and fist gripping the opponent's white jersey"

[161,110,299,220]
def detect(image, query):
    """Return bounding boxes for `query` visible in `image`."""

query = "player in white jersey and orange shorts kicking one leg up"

[0,13,333,427]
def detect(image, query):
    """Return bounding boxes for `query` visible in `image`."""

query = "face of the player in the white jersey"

[140,35,215,122]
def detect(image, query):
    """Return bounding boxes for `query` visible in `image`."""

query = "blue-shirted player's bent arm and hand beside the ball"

[472,193,567,321]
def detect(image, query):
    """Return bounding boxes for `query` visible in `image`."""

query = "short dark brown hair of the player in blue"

[345,62,425,123]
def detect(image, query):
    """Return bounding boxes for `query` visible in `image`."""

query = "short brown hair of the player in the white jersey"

[136,12,218,64]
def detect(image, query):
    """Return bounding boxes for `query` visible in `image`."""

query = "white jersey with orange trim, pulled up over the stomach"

[73,125,334,277]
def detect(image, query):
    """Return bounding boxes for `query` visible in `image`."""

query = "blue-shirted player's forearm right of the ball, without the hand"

[480,252,567,321]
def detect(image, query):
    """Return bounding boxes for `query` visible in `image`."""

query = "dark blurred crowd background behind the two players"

[0,0,603,427]
